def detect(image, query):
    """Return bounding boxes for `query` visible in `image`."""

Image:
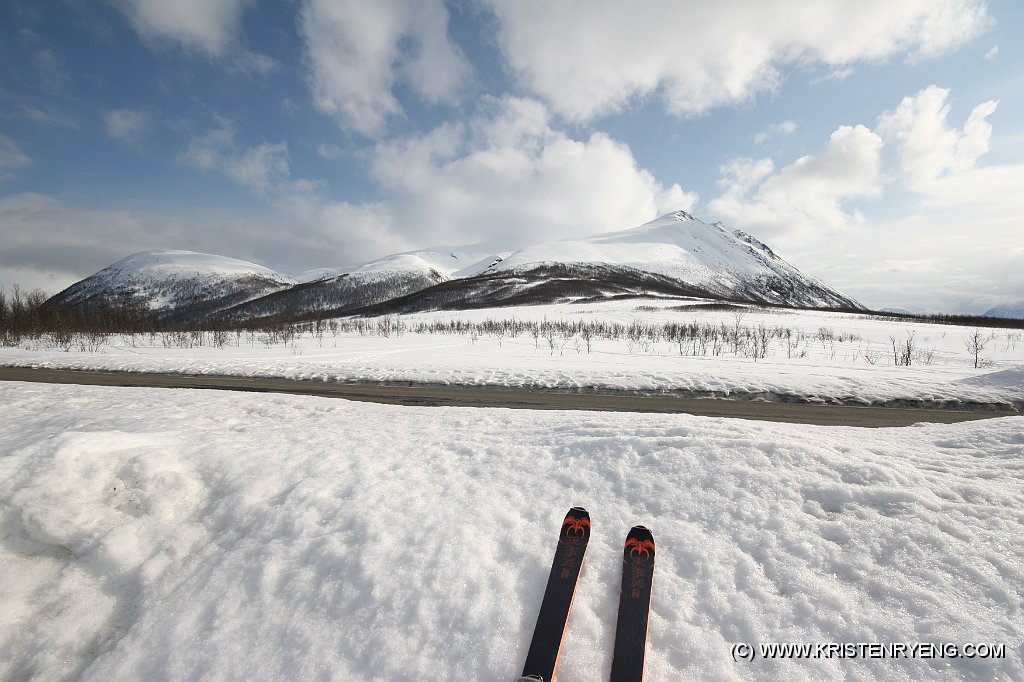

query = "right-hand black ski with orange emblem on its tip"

[611,525,654,682]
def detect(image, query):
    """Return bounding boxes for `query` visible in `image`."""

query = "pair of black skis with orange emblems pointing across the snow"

[519,507,654,682]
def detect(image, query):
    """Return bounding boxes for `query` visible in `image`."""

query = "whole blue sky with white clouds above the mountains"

[0,0,1024,312]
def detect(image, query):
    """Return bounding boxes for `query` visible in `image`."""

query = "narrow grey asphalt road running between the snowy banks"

[0,367,1013,427]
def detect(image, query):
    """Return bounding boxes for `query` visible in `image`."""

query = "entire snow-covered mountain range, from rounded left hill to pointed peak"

[46,211,862,322]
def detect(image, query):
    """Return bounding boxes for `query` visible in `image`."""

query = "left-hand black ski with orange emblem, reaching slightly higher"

[522,507,590,682]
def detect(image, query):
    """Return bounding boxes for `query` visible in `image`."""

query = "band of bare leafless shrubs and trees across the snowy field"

[0,286,1024,368]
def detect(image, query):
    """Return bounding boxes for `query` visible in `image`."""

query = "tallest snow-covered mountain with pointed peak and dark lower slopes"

[323,211,863,312]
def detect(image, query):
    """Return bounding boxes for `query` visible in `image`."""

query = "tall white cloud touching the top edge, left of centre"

[301,0,471,136]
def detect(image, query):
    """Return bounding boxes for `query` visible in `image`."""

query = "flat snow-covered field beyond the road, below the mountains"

[0,300,1024,411]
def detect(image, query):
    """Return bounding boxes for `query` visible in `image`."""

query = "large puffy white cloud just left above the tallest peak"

[372,97,696,244]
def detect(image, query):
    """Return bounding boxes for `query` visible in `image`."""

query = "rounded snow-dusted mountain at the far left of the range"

[49,251,297,322]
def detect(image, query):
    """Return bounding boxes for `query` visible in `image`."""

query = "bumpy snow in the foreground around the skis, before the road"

[0,382,1024,682]
